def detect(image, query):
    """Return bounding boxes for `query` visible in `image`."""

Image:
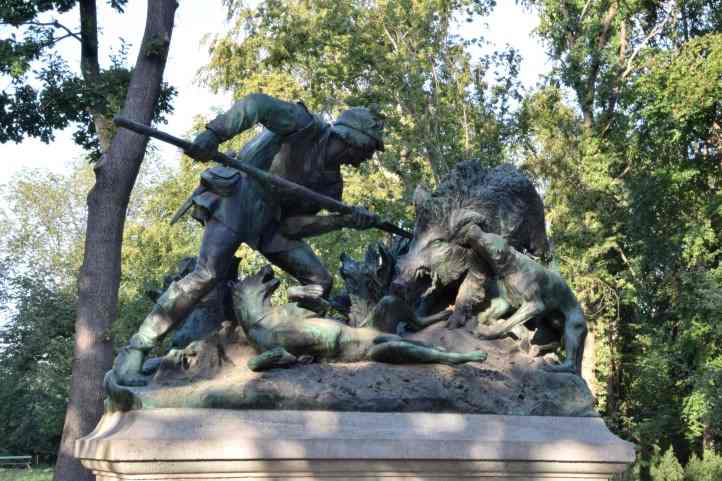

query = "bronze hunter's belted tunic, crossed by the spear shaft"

[192,94,343,251]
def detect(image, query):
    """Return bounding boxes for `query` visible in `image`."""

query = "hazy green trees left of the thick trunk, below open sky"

[0,167,92,460]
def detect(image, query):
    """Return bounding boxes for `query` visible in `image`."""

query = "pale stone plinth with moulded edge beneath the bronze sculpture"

[75,409,634,481]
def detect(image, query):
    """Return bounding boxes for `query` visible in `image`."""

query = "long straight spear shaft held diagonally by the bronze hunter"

[113,117,412,239]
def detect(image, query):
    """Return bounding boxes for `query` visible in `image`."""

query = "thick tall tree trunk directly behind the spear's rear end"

[53,0,177,481]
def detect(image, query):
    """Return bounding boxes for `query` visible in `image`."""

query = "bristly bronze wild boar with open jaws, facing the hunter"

[391,161,549,328]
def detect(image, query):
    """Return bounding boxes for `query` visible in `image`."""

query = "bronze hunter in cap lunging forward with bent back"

[113,94,384,386]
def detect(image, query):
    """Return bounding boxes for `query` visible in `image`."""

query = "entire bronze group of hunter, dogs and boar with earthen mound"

[106,94,595,415]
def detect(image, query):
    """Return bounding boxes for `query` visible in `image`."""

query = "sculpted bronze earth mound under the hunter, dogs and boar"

[106,323,598,416]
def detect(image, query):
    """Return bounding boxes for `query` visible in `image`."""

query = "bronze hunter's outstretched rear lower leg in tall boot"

[113,269,215,386]
